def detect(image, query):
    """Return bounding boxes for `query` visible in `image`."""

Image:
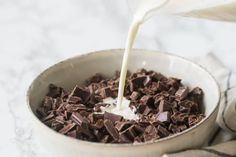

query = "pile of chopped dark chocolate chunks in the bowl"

[36,69,204,143]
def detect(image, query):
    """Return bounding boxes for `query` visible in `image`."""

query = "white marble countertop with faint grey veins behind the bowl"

[0,0,236,157]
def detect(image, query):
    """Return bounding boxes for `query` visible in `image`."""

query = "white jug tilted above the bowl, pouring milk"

[128,0,236,22]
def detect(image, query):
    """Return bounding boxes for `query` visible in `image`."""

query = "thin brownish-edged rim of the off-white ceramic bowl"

[26,48,221,148]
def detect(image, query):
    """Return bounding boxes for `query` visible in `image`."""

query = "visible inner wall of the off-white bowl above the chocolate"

[28,49,219,124]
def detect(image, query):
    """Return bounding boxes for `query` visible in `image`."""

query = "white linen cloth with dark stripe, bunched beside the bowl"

[163,53,236,157]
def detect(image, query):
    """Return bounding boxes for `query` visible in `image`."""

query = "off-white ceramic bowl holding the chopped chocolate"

[27,49,220,157]
